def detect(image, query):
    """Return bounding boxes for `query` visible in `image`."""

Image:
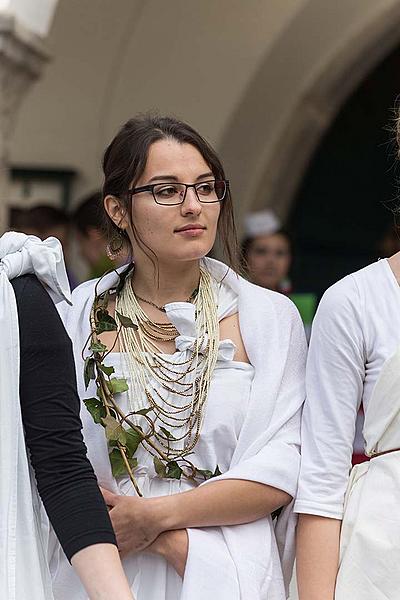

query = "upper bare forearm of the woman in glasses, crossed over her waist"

[152,479,291,531]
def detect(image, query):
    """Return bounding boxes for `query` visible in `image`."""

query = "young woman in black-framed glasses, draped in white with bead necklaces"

[56,116,306,600]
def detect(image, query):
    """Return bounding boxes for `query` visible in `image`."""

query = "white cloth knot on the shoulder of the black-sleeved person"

[0,231,71,304]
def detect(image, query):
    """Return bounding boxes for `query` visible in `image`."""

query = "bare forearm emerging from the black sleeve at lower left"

[71,544,134,600]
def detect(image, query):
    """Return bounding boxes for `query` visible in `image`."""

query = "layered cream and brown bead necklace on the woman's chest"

[116,267,219,460]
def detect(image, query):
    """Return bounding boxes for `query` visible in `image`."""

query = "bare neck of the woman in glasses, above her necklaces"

[132,260,200,306]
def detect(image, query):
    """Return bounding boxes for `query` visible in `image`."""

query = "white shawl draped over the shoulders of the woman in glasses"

[62,259,307,600]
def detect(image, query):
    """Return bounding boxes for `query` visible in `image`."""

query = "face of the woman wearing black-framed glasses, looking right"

[120,140,220,264]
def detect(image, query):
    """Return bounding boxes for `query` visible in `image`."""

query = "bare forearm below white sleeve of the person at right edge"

[296,515,341,600]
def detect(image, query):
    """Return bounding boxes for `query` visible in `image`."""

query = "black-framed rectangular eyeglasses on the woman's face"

[128,179,229,206]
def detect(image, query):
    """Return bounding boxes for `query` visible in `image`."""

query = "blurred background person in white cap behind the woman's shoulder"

[242,209,316,339]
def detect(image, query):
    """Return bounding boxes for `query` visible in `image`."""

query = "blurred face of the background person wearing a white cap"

[247,233,292,290]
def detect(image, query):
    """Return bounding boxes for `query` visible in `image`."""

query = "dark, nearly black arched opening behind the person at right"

[289,47,400,295]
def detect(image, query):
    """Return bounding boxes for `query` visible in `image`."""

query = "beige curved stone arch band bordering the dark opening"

[219,0,400,231]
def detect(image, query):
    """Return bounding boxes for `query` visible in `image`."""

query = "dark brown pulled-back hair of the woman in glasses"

[103,114,240,271]
